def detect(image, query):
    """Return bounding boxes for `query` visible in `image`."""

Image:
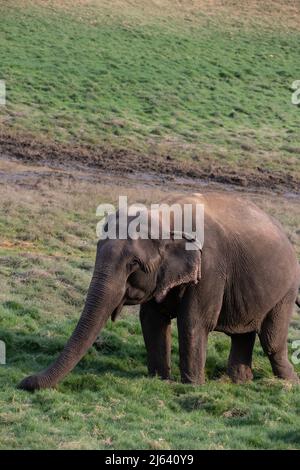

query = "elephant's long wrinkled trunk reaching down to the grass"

[19,266,124,390]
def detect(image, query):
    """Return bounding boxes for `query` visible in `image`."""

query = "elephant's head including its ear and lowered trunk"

[19,208,201,390]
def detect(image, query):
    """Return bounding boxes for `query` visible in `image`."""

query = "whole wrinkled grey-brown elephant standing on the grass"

[20,193,300,390]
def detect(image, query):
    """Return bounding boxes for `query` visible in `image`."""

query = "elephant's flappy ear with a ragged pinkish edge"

[154,239,201,302]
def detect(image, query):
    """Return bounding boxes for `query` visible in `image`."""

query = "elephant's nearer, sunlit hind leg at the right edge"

[259,293,299,383]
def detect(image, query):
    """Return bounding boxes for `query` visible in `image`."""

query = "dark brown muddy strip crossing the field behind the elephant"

[0,132,300,194]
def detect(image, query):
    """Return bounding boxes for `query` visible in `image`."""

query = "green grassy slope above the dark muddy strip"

[0,2,300,174]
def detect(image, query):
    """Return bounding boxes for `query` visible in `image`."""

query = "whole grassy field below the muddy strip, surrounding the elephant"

[0,161,300,449]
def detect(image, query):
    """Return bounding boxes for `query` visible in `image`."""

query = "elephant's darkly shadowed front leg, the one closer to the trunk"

[140,301,171,379]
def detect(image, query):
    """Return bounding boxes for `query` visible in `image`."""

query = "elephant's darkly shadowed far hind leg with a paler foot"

[227,331,256,383]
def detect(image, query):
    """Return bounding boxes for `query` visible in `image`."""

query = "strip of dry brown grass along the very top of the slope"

[14,0,300,29]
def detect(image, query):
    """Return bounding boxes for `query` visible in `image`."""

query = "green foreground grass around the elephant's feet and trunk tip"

[0,304,300,449]
